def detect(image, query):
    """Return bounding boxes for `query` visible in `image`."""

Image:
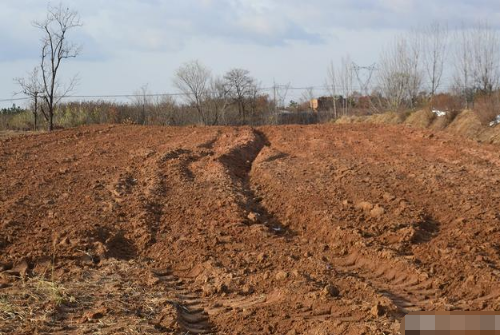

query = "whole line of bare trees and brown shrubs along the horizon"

[8,4,500,131]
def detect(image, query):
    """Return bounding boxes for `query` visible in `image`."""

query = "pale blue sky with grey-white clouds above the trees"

[0,0,500,106]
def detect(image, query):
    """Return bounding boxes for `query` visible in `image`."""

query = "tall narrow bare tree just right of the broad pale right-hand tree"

[422,22,448,105]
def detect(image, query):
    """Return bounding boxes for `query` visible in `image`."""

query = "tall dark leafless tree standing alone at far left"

[33,4,82,131]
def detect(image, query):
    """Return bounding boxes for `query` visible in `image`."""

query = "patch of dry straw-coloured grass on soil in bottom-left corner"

[0,259,177,335]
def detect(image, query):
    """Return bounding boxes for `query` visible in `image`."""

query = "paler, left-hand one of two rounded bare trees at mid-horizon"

[174,60,216,125]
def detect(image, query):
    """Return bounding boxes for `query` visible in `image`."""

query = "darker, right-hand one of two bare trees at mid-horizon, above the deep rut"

[224,69,256,123]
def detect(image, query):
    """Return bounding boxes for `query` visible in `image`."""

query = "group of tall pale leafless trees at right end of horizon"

[326,22,500,118]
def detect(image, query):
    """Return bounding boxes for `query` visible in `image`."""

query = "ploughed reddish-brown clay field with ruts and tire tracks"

[0,124,500,335]
